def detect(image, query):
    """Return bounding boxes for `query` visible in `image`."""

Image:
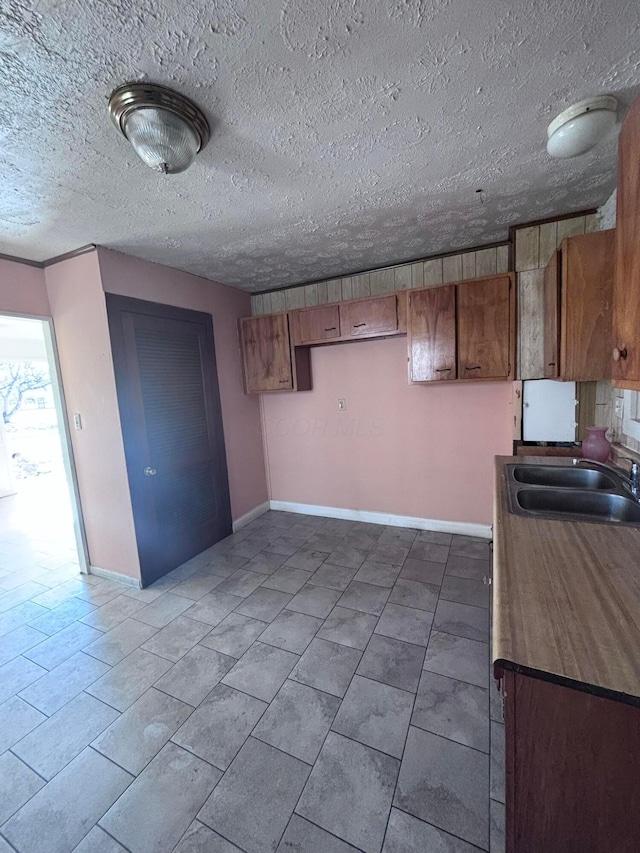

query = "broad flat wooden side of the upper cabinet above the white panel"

[559,231,616,382]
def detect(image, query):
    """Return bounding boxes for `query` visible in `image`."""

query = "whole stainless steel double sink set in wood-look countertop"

[505,464,640,525]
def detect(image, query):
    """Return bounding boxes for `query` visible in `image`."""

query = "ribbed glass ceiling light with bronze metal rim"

[109,83,209,175]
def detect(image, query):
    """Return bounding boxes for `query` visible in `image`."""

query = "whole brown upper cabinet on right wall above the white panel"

[543,231,614,382]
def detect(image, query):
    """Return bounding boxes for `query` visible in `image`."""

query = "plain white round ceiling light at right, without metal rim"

[547,95,618,158]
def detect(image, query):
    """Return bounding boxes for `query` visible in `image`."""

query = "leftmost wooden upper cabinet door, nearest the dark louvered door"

[240,314,294,394]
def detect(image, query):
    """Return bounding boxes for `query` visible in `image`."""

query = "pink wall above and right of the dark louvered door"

[98,248,268,520]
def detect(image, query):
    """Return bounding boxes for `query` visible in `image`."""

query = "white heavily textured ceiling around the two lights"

[0,0,640,290]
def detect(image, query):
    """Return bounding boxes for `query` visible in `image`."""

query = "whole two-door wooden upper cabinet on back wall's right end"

[407,275,515,382]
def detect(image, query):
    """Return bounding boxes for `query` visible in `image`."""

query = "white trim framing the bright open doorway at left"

[0,311,89,575]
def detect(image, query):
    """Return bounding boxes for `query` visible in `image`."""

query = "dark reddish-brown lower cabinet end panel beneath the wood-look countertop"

[496,669,640,853]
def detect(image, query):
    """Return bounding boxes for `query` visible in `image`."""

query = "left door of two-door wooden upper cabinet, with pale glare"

[407,285,456,382]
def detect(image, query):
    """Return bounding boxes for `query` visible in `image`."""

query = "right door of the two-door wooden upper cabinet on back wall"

[456,276,512,379]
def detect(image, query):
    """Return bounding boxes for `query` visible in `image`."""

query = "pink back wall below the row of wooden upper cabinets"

[262,338,512,524]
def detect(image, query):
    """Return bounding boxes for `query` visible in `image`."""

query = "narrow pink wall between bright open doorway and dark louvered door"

[45,252,140,578]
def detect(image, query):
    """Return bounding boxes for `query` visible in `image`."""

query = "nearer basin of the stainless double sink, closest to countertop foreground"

[515,490,640,524]
